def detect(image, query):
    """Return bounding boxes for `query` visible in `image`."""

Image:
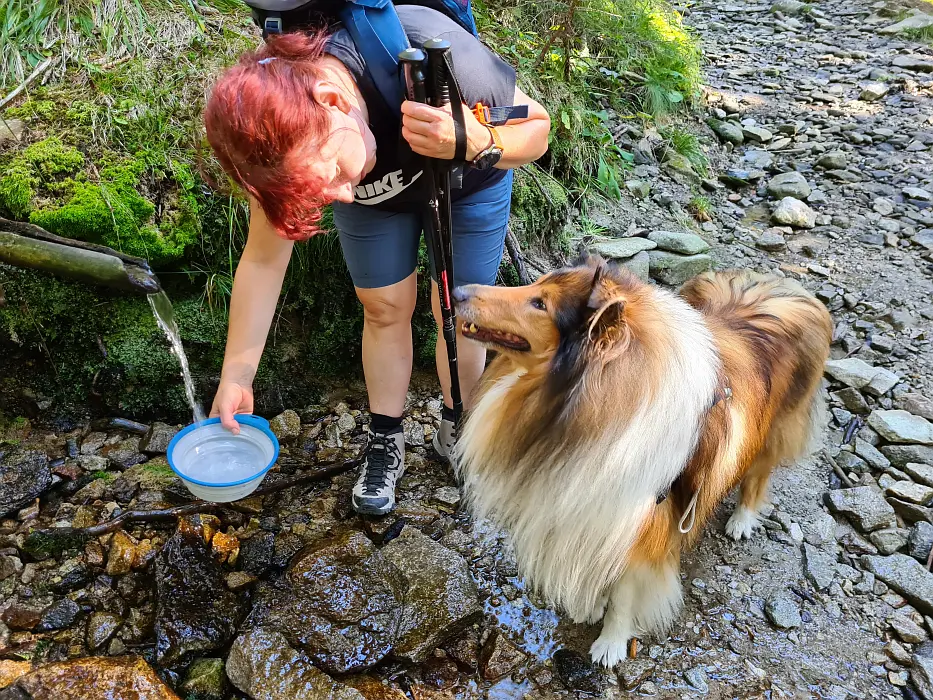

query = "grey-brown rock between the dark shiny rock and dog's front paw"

[382,527,482,663]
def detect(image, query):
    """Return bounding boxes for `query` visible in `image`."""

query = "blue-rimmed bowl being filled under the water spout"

[166,414,279,503]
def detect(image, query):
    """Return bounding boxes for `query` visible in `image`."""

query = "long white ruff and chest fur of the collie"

[457,289,720,621]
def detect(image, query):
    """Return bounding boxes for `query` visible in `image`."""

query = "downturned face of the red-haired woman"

[312,106,376,204]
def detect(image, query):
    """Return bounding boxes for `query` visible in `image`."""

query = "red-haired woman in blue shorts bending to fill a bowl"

[205,5,550,514]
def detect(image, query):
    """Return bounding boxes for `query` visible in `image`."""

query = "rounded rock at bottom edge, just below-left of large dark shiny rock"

[226,627,364,700]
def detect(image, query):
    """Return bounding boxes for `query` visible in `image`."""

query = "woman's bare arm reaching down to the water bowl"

[211,197,294,432]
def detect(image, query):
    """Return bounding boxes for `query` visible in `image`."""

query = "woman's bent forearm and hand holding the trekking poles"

[402,85,551,170]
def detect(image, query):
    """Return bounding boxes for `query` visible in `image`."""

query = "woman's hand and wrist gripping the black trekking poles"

[402,100,492,161]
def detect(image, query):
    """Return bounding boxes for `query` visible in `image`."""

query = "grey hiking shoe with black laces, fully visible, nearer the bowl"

[352,428,405,515]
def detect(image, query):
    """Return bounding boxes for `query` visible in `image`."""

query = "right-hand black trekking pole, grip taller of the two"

[424,39,463,429]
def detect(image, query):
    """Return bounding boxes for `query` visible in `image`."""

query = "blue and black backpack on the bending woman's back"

[243,0,479,113]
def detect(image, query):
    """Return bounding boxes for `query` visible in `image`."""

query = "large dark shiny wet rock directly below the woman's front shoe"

[263,531,406,673]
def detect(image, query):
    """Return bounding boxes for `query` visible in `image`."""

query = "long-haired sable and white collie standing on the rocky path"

[454,256,832,666]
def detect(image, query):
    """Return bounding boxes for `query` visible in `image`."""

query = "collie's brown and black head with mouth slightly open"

[454,255,650,379]
